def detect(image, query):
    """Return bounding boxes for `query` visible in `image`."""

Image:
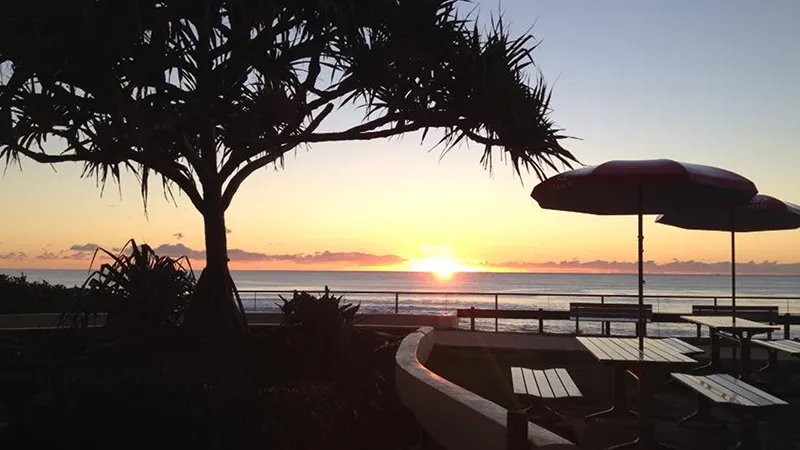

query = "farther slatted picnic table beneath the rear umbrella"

[681,315,779,379]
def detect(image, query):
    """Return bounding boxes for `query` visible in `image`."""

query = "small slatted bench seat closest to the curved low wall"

[511,367,583,420]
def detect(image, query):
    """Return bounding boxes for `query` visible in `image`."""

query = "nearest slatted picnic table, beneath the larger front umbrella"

[577,337,697,449]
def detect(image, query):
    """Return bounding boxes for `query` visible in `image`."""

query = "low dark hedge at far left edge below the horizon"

[0,274,79,314]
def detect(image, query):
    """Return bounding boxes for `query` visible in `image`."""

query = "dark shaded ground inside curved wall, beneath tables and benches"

[427,338,800,450]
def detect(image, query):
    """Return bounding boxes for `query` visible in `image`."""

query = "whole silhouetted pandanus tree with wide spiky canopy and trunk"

[0,0,576,333]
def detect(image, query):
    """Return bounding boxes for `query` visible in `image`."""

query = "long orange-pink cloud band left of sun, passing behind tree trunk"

[148,244,405,266]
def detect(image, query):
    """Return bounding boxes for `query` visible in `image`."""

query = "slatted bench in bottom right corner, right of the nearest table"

[672,373,788,448]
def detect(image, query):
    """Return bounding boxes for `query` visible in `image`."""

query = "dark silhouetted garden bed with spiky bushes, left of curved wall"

[0,251,419,450]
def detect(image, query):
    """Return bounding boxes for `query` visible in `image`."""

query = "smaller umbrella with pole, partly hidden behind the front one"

[656,194,800,320]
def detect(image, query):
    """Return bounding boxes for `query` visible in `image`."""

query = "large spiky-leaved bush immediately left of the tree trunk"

[60,239,197,331]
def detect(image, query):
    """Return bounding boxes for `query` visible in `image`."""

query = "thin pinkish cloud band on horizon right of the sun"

[483,259,800,275]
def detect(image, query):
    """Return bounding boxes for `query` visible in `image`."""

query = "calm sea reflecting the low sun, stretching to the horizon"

[0,269,800,335]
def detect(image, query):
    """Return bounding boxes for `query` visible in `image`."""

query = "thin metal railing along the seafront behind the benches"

[239,289,800,338]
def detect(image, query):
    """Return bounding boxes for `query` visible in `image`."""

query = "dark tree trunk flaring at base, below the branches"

[184,196,247,337]
